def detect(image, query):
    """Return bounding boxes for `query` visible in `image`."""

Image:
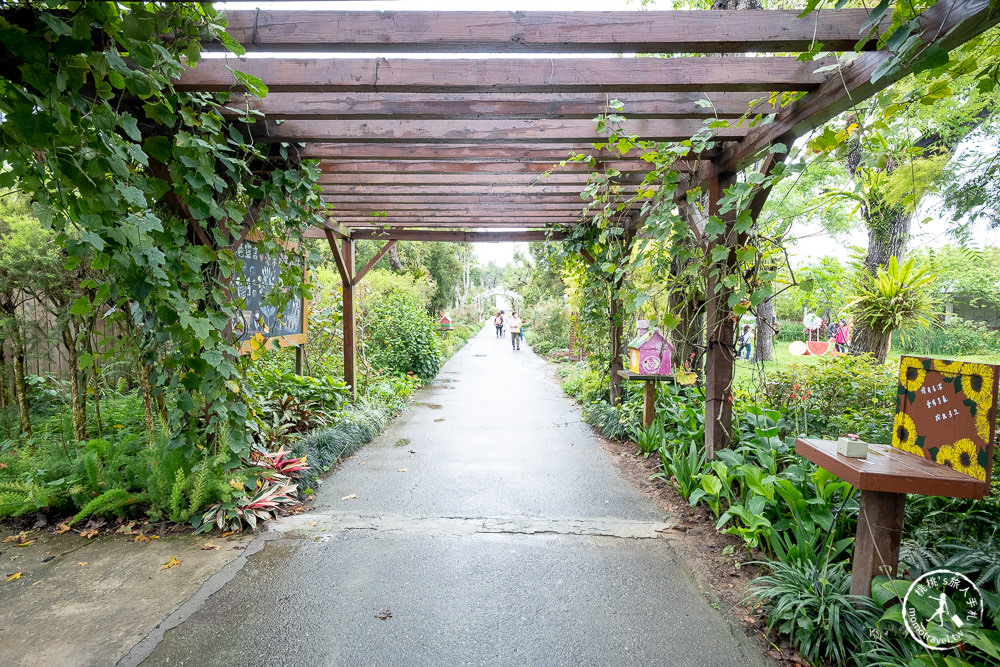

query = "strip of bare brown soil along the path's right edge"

[597,434,809,667]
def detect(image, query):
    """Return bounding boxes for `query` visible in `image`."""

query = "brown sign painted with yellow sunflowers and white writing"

[892,357,1000,484]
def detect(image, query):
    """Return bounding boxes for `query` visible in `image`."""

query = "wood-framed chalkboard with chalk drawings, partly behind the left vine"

[230,241,308,352]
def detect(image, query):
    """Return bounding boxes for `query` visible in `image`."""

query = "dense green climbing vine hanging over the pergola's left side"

[0,2,322,454]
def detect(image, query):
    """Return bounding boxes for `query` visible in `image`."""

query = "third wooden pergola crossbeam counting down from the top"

[222,92,772,120]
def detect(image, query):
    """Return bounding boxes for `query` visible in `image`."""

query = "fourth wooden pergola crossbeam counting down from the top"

[253,118,748,144]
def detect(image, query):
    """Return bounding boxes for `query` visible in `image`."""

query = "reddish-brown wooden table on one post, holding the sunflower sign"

[795,438,989,596]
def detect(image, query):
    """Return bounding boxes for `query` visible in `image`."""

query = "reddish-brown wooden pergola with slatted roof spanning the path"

[177,0,1000,455]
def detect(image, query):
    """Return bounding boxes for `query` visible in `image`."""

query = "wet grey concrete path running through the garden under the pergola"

[127,326,770,667]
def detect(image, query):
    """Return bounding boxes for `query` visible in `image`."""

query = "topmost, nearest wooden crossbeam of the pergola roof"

[217,9,884,53]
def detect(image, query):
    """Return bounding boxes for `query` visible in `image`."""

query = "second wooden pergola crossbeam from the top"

[174,56,833,95]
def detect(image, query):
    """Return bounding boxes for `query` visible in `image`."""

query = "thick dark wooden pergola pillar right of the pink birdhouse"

[705,174,736,459]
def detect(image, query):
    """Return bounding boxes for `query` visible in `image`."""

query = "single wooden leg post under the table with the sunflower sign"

[851,491,906,597]
